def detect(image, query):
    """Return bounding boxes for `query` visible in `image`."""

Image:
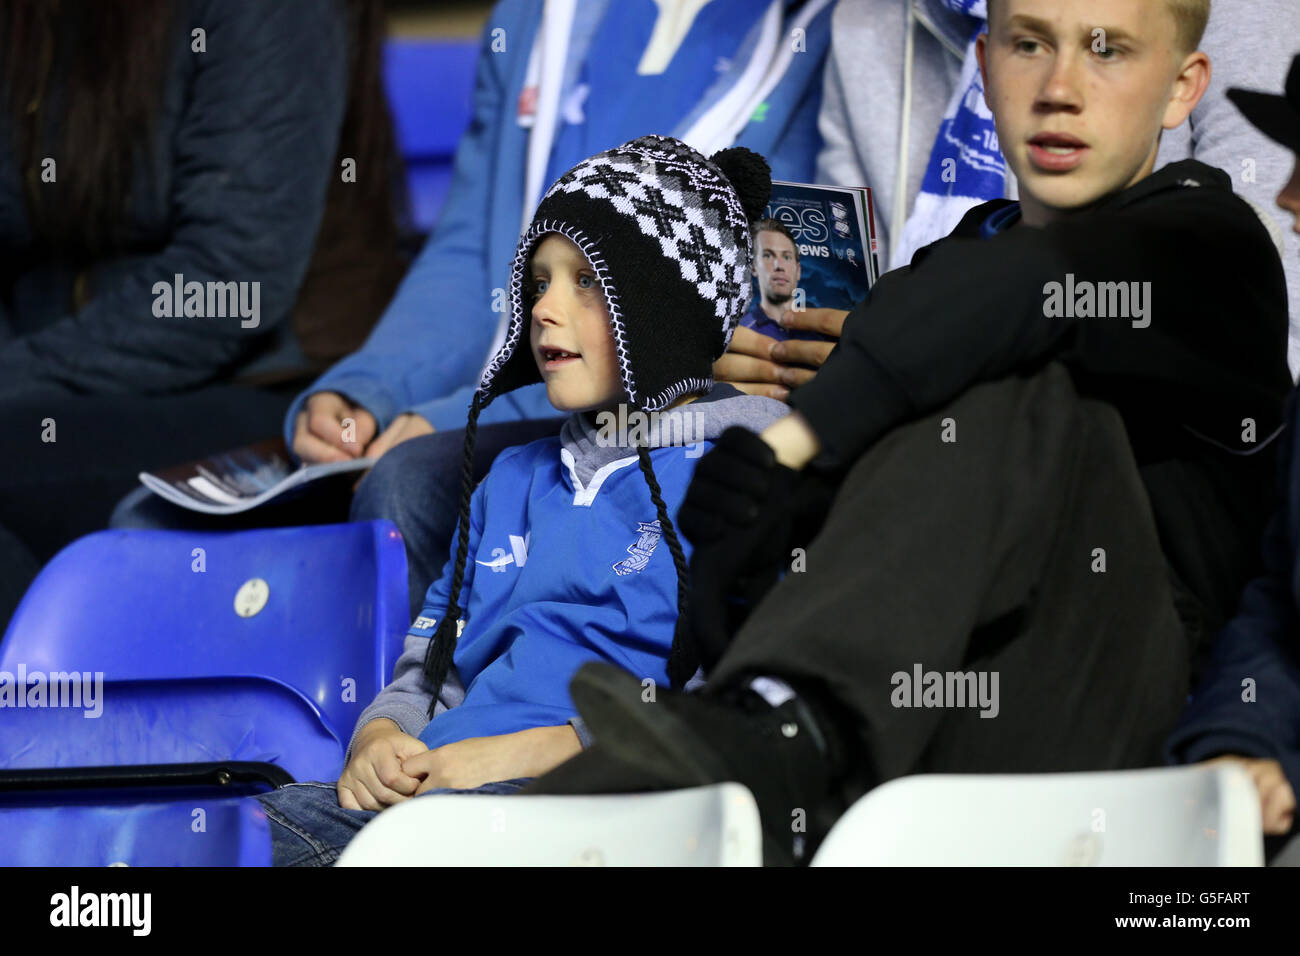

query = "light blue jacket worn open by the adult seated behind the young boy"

[285,0,832,445]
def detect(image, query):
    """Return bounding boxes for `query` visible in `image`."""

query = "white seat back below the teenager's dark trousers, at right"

[813,767,1264,866]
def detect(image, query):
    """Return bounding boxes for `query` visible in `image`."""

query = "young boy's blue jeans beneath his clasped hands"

[252,778,532,866]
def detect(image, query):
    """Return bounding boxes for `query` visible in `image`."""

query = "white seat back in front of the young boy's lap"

[337,783,762,866]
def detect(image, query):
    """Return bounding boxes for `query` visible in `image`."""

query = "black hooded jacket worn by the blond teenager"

[790,160,1291,644]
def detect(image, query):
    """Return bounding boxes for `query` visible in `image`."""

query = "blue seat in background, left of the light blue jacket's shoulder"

[384,38,478,233]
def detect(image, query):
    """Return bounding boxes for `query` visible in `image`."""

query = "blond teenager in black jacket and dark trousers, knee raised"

[529,0,1291,861]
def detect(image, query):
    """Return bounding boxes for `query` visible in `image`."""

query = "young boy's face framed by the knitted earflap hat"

[529,233,627,411]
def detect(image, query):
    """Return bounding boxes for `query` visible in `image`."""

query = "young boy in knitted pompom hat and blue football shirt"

[260,137,784,865]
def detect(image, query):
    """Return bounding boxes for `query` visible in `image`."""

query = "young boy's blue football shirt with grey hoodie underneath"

[345,385,787,748]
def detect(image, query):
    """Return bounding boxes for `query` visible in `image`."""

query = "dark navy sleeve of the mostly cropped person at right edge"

[1165,392,1300,816]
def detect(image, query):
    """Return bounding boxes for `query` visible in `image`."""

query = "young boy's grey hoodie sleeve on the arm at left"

[343,481,488,766]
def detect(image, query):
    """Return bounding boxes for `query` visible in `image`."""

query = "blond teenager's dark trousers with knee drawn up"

[710,365,1190,783]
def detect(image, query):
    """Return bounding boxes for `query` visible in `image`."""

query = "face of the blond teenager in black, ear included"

[978,0,1209,225]
